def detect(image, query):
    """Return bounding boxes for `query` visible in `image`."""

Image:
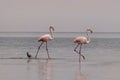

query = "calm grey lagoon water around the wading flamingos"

[0,32,120,80]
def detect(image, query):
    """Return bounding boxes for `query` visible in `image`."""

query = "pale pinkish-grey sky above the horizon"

[0,0,120,32]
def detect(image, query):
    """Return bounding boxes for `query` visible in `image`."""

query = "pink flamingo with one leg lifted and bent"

[74,28,93,62]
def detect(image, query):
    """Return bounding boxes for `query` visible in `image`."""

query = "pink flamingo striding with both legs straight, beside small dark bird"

[35,26,54,58]
